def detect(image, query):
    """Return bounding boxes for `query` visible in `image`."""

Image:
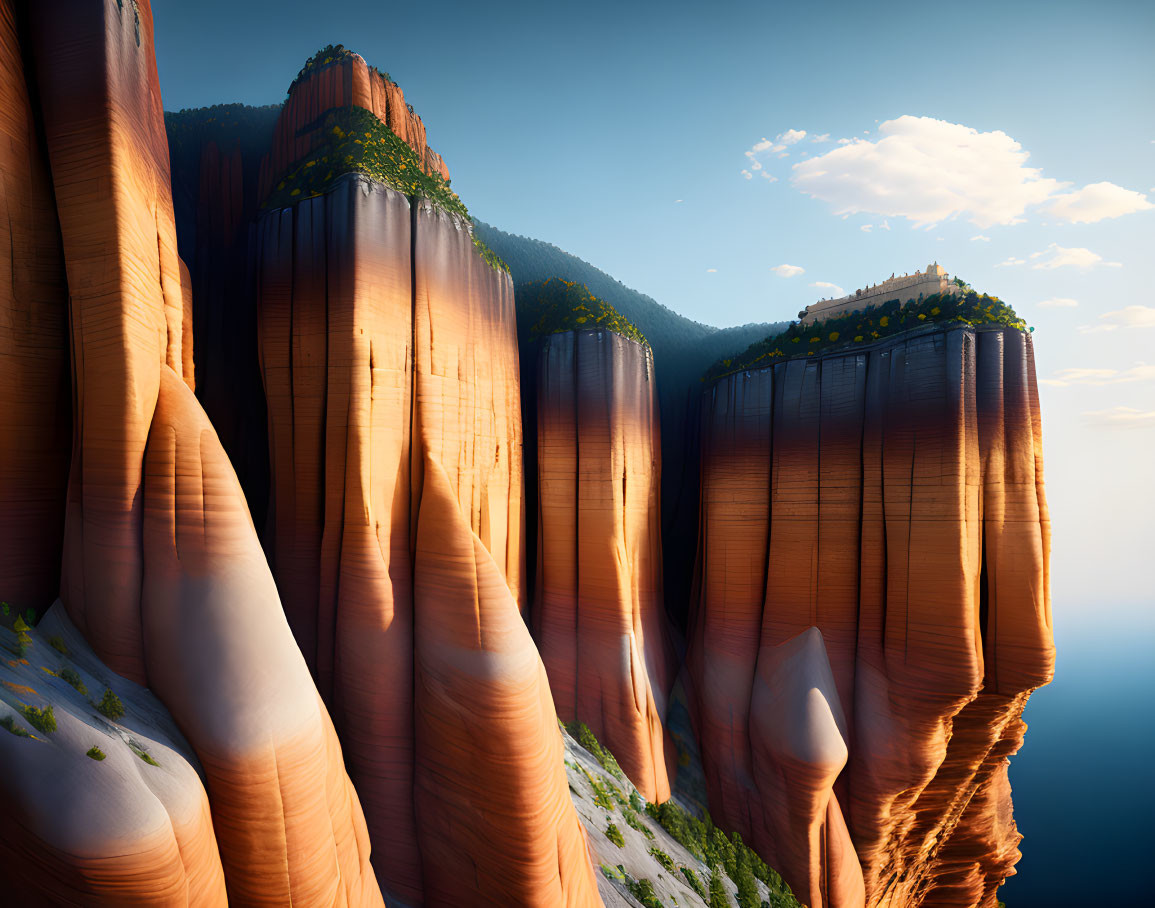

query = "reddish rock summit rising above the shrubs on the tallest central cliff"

[260,45,449,199]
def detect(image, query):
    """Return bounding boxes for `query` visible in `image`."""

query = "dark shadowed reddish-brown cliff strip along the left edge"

[0,0,70,611]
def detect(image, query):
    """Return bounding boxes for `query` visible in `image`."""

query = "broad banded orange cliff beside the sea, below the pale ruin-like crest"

[688,328,1053,908]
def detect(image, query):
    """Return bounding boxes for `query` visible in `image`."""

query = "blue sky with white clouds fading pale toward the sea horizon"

[152,0,1155,619]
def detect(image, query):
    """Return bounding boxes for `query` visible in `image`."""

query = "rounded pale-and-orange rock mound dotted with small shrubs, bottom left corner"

[0,603,229,908]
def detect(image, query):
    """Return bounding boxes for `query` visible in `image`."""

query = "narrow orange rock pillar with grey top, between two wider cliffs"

[532,330,673,802]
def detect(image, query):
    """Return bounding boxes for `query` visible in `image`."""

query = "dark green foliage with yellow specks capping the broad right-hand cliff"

[705,289,1028,381]
